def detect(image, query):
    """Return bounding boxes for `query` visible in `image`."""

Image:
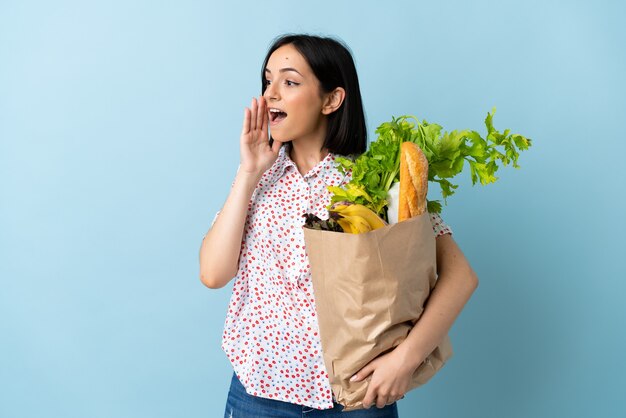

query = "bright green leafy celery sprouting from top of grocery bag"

[328,108,531,219]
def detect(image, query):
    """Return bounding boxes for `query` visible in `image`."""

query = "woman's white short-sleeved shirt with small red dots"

[214,146,451,409]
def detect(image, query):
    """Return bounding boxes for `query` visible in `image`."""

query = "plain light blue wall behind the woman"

[0,0,626,418]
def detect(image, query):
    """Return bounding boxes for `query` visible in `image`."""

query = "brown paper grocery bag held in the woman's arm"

[304,213,452,411]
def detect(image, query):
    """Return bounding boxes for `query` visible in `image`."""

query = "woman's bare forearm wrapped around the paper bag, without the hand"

[394,234,478,369]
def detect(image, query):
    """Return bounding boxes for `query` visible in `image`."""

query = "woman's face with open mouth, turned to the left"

[263,44,327,142]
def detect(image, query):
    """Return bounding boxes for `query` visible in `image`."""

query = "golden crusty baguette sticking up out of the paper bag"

[398,141,428,222]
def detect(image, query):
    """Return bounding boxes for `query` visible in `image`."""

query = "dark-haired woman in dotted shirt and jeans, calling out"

[200,35,478,418]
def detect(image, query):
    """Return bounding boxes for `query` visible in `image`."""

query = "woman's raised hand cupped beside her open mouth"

[240,96,282,176]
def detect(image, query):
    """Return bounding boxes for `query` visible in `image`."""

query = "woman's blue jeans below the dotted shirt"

[224,373,398,418]
